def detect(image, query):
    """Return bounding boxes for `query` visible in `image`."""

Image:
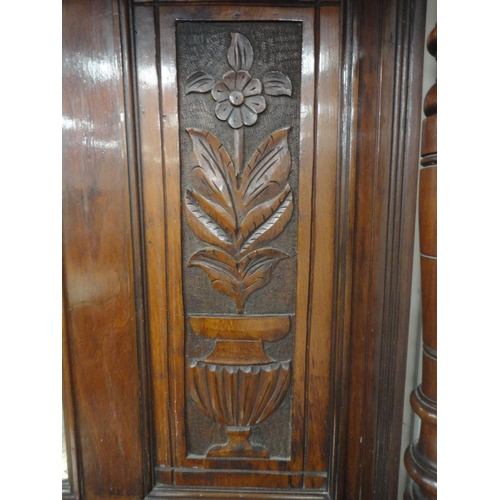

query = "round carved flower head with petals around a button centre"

[212,70,266,128]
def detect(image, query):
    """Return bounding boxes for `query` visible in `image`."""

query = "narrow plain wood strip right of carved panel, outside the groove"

[304,7,340,476]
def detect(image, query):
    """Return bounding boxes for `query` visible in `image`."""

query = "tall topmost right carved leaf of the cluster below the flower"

[240,128,291,211]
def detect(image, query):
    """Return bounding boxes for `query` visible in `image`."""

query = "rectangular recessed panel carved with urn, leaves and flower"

[176,22,301,459]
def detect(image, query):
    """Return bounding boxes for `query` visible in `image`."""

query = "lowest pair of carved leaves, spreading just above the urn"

[188,248,288,313]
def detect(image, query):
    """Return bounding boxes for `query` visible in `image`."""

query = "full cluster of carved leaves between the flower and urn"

[184,129,293,312]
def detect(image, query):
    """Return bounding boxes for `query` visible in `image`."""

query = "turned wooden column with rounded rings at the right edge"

[405,23,437,500]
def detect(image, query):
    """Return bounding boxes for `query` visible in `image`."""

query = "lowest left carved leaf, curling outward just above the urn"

[188,249,240,302]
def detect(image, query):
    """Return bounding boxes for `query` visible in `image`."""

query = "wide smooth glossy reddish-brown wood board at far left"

[63,0,143,499]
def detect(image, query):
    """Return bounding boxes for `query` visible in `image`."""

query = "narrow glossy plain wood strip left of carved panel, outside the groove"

[134,7,171,466]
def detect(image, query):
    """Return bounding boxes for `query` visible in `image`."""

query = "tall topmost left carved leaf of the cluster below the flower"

[186,128,236,219]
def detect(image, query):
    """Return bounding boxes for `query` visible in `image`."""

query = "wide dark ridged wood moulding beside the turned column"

[344,0,425,499]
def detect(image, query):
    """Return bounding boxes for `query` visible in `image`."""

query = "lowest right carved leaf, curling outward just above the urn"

[238,248,288,302]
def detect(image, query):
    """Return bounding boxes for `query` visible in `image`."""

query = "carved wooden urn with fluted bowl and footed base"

[188,316,291,458]
